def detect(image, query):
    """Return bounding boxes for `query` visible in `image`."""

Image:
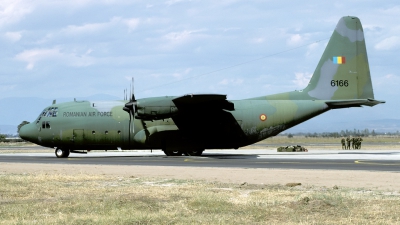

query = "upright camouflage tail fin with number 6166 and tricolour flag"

[303,16,374,100]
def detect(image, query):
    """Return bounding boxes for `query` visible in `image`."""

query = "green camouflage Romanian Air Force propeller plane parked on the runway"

[19,16,384,158]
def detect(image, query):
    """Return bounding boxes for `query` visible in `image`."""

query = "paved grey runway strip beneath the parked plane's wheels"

[0,150,400,172]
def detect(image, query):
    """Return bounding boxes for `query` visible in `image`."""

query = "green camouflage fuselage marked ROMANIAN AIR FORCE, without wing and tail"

[19,97,328,150]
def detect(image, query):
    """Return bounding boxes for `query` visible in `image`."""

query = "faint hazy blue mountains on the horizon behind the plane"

[0,94,400,134]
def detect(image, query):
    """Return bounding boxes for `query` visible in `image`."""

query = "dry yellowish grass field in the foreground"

[0,174,400,224]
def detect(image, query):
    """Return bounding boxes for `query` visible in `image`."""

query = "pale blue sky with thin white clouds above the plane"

[0,0,400,119]
